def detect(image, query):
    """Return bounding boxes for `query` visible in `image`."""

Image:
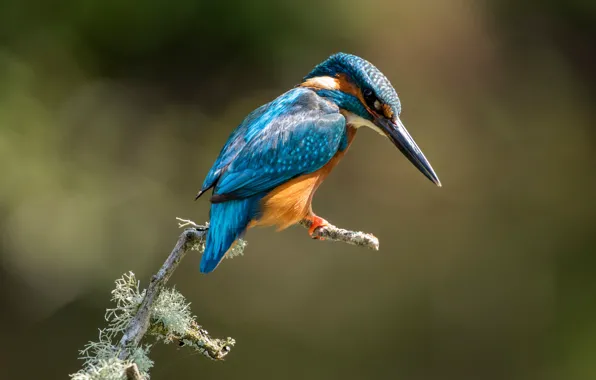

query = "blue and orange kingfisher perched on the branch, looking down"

[195,53,441,273]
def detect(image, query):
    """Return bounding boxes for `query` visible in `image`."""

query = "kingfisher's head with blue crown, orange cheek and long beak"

[300,53,441,186]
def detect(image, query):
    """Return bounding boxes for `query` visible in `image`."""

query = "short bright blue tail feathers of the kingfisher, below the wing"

[201,197,259,273]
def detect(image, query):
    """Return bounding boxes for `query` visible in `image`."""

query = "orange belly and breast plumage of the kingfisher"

[249,127,356,230]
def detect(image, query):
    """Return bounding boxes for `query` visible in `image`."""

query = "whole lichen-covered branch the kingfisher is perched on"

[71,218,379,380]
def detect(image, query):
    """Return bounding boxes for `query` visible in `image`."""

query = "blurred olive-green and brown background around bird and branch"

[0,0,596,380]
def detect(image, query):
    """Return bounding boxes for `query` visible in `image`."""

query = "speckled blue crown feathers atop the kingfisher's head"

[304,53,401,117]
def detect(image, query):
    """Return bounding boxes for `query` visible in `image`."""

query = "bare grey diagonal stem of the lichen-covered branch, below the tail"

[118,226,207,360]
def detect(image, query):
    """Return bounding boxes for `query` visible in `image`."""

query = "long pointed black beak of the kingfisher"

[375,117,441,187]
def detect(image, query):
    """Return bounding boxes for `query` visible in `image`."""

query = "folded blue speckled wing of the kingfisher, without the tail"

[199,88,347,202]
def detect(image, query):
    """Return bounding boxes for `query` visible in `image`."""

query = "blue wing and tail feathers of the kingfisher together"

[201,87,348,273]
